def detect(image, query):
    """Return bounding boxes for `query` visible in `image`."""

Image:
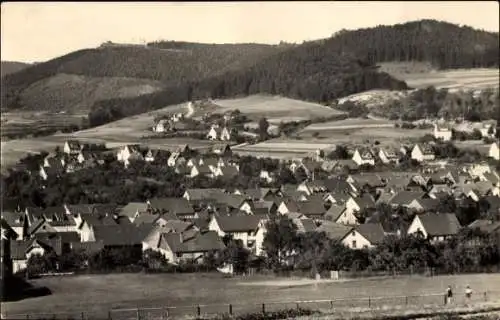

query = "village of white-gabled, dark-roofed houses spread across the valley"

[2,112,500,273]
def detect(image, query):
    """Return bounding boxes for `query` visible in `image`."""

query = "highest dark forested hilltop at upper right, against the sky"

[327,19,500,69]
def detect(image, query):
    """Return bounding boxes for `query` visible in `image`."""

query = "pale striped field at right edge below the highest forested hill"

[396,69,500,89]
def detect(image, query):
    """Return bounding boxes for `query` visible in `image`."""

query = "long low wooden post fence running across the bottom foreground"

[2,291,500,320]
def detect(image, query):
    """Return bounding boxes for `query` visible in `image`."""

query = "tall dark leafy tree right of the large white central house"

[263,217,297,270]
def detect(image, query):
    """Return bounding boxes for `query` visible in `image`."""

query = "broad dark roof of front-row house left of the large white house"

[160,231,224,253]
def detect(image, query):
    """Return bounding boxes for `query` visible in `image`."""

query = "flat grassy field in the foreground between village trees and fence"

[2,274,500,319]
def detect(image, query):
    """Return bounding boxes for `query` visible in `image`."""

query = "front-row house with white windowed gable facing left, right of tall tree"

[341,223,385,249]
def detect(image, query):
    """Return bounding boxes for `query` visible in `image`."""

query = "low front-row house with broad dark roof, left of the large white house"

[146,229,225,264]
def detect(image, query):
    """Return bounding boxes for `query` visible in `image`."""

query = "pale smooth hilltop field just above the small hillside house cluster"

[209,95,344,124]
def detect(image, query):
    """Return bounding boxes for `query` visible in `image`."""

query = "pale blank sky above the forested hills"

[1,1,499,62]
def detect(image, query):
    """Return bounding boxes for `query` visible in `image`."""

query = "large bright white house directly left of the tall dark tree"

[208,215,266,256]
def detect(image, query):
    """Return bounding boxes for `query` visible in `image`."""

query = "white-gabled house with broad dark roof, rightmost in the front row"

[407,213,460,241]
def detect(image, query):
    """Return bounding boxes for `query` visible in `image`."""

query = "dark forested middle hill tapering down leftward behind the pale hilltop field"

[89,42,407,125]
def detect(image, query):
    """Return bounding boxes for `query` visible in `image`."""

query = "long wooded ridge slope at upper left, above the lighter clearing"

[2,42,284,110]
